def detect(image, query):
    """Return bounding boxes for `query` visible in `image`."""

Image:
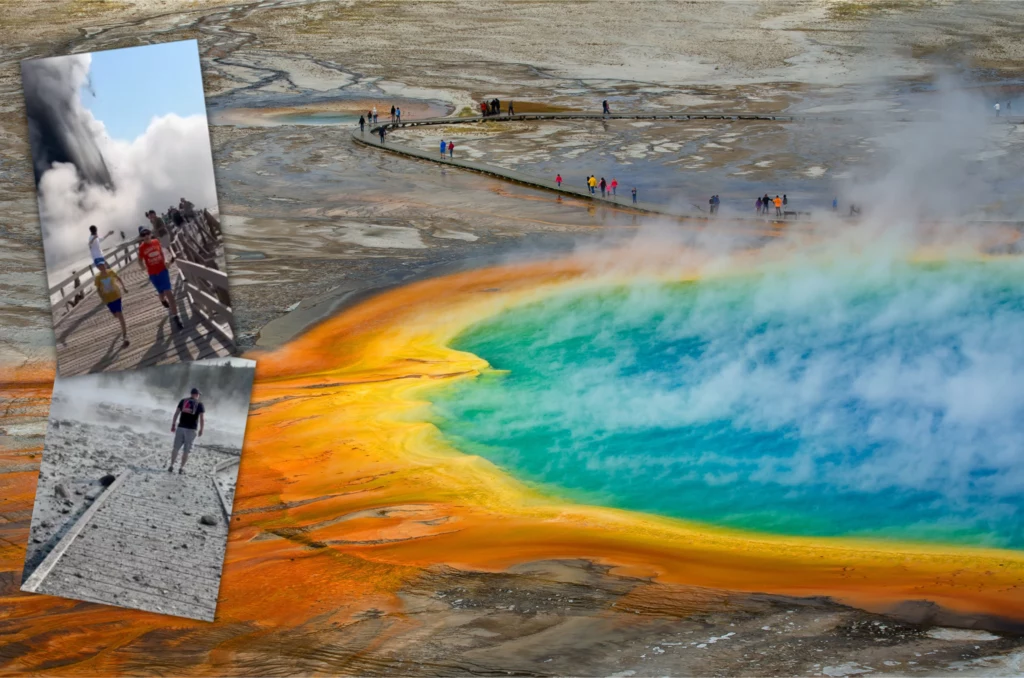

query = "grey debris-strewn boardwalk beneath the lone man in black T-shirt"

[22,449,238,622]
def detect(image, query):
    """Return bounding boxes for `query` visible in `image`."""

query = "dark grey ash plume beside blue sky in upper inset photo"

[22,55,114,188]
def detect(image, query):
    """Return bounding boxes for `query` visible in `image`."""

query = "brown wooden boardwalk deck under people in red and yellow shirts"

[53,262,236,377]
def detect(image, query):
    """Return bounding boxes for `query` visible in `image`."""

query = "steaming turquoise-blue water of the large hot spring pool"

[431,262,1024,548]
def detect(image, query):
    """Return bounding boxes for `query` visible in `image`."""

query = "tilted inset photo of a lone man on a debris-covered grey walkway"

[22,357,256,621]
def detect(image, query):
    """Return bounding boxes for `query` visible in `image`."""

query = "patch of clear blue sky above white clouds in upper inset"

[82,40,206,141]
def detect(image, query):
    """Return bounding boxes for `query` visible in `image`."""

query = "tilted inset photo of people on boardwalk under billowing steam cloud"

[22,40,238,377]
